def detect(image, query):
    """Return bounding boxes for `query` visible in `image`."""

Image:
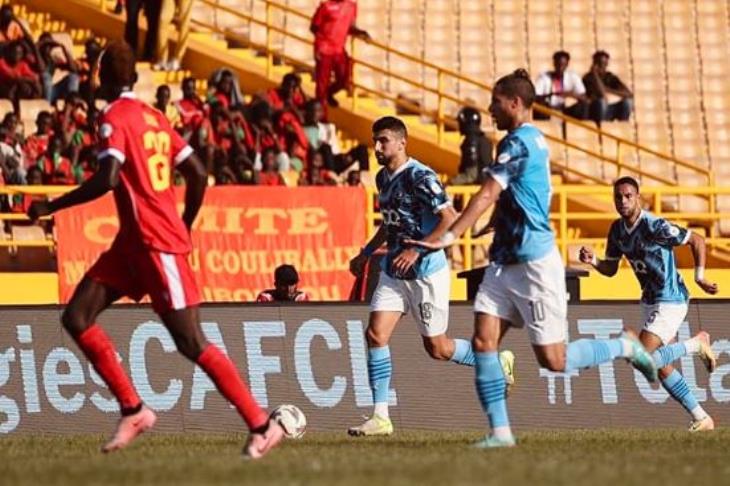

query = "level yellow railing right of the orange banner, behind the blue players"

[366,184,730,269]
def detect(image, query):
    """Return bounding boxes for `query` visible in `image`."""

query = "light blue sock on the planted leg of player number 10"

[474,351,509,429]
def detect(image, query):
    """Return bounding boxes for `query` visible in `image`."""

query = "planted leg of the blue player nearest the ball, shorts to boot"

[347,272,408,436]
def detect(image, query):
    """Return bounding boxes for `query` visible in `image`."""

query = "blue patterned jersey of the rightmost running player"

[606,211,690,304]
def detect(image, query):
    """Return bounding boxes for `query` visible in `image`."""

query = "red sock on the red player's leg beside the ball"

[197,344,269,429]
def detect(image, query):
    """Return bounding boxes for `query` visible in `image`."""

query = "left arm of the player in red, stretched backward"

[28,156,122,221]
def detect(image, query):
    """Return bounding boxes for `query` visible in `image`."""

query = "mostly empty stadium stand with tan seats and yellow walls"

[1,0,730,304]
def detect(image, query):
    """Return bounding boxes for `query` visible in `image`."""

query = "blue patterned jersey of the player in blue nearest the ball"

[375,158,451,280]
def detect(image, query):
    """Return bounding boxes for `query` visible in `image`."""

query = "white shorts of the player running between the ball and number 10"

[370,266,451,336]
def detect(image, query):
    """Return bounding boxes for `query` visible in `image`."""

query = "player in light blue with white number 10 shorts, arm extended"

[408,69,656,448]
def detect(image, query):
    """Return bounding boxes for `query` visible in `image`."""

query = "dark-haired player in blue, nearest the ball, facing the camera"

[348,117,512,436]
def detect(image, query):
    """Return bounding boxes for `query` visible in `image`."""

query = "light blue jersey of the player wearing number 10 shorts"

[487,123,555,265]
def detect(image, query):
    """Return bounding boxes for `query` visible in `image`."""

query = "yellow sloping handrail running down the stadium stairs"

[193,0,713,185]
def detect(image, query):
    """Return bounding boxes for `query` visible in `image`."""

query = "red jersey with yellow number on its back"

[99,91,193,253]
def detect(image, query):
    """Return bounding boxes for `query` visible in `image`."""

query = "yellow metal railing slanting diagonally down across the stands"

[178,0,714,185]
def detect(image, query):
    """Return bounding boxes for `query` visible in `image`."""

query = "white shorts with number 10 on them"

[474,247,568,345]
